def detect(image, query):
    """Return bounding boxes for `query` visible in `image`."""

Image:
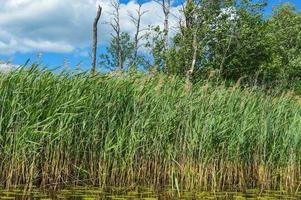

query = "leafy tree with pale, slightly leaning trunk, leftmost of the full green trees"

[167,0,208,79]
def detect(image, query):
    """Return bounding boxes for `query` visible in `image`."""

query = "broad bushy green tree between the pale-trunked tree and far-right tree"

[206,1,269,81]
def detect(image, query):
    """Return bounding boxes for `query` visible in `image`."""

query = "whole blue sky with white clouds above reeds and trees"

[0,0,301,68]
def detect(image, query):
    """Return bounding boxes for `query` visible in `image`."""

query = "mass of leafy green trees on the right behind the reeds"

[163,1,301,88]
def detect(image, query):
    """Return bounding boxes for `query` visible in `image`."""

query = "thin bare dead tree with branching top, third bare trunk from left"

[129,4,148,68]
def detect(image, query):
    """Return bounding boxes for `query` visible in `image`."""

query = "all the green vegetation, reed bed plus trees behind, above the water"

[0,0,301,193]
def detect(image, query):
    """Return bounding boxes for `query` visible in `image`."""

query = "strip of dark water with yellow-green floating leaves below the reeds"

[0,187,301,200]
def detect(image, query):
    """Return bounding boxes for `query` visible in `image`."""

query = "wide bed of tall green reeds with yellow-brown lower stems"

[0,68,301,192]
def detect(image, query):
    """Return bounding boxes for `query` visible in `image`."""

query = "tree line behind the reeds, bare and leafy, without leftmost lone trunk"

[100,0,301,94]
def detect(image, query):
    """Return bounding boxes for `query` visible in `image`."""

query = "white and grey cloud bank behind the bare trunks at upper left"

[0,0,182,55]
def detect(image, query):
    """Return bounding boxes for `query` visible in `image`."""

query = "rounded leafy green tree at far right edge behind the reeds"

[262,4,301,87]
